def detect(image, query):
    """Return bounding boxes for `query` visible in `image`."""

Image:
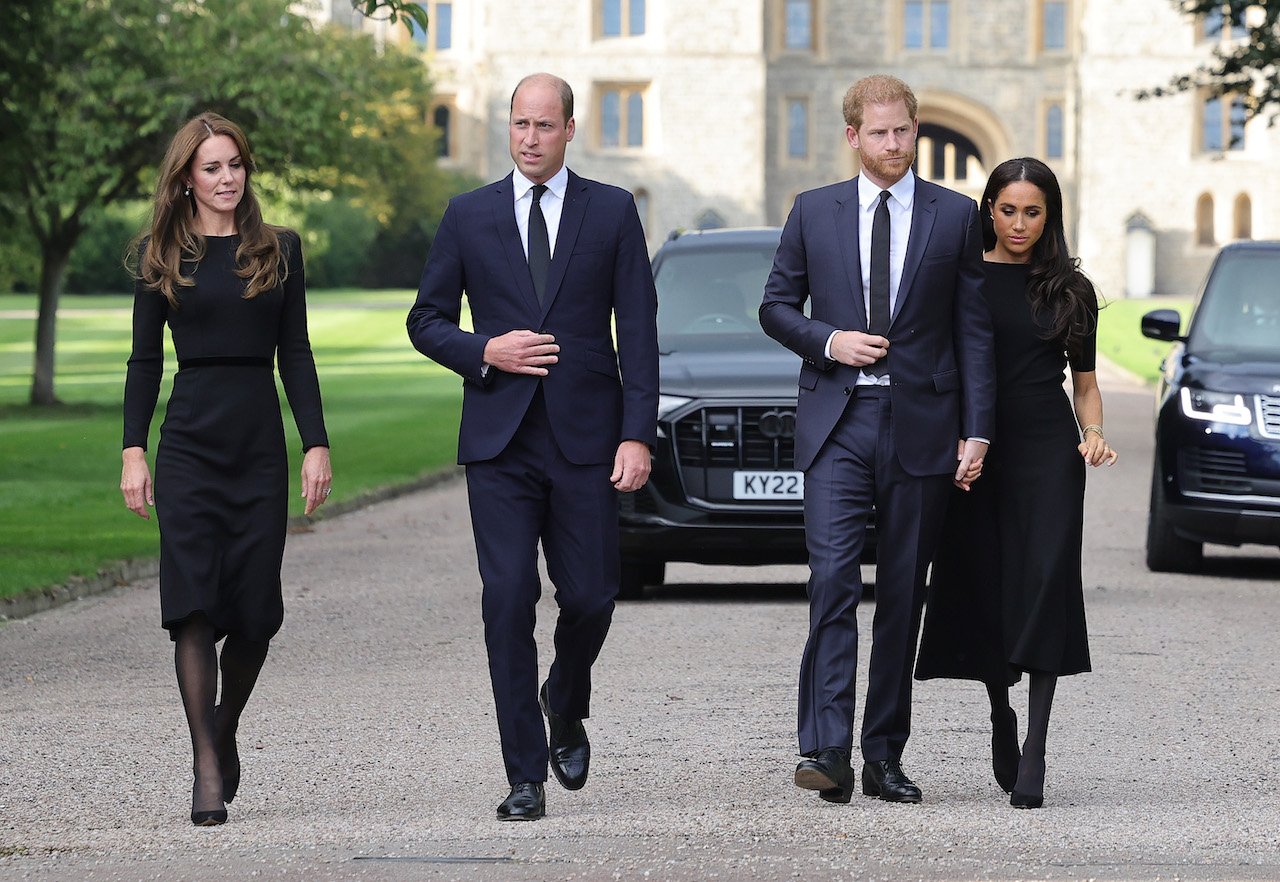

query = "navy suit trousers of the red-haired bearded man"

[797,387,951,762]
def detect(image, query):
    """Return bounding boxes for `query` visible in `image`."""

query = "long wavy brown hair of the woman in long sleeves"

[138,111,288,307]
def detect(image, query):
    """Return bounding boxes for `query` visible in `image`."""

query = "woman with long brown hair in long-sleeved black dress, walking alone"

[120,113,333,826]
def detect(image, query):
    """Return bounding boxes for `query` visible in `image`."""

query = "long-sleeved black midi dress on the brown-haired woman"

[124,230,329,641]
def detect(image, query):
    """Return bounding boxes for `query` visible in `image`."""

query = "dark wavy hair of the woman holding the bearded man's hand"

[978,156,1098,355]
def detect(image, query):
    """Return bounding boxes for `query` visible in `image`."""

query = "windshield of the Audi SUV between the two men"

[654,242,781,352]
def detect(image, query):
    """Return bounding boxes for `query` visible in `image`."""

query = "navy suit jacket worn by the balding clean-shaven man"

[407,172,658,465]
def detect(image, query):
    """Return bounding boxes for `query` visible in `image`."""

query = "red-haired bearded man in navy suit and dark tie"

[760,76,995,803]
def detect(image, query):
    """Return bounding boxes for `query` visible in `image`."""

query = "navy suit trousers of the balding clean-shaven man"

[466,387,620,783]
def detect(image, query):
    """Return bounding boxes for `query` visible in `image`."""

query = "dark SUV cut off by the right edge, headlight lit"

[1142,242,1280,572]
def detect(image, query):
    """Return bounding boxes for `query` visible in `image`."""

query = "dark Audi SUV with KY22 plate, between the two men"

[620,228,875,599]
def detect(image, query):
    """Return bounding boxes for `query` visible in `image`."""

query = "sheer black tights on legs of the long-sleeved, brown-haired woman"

[174,613,268,812]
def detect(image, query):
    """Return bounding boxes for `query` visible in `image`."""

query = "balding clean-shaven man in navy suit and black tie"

[407,73,658,821]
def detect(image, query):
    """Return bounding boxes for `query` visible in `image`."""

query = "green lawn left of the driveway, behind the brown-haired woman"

[0,291,462,597]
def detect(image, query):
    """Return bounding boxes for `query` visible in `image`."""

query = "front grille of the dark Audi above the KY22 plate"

[675,406,795,469]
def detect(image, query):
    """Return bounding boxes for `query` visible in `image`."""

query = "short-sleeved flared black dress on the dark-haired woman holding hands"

[915,262,1096,685]
